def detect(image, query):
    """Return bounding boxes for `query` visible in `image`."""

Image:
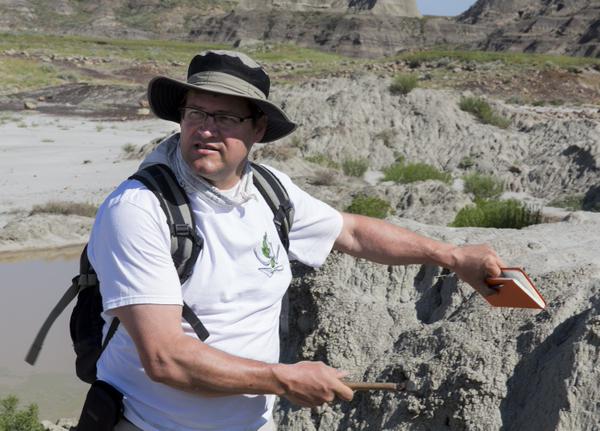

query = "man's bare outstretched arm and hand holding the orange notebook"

[333,213,505,295]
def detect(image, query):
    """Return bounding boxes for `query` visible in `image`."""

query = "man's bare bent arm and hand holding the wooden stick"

[111,304,353,407]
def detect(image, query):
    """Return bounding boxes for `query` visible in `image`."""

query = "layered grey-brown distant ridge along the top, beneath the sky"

[0,0,600,57]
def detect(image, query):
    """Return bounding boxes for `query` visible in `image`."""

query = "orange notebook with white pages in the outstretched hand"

[484,268,546,310]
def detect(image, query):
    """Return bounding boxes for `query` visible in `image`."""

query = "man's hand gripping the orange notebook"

[449,244,506,296]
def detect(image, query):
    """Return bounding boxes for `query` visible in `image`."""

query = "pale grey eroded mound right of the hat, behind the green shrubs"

[260,75,600,204]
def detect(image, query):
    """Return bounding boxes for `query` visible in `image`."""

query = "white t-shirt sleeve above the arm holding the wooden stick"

[88,181,183,310]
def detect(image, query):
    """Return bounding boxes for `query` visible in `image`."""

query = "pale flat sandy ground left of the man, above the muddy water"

[0,112,177,261]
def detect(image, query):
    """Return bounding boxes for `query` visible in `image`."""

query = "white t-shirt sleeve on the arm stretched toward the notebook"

[268,166,343,267]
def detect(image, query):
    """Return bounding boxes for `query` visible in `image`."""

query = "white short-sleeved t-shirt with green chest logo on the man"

[88,168,342,431]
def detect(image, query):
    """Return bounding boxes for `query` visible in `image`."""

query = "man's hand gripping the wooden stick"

[273,361,354,407]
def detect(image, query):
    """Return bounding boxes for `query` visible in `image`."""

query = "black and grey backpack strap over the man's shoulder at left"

[129,164,209,343]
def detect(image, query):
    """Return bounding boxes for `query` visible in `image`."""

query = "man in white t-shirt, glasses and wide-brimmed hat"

[88,51,502,431]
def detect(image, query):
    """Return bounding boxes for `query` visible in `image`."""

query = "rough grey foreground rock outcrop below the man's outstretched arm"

[277,214,600,431]
